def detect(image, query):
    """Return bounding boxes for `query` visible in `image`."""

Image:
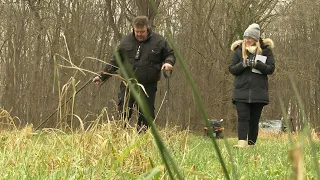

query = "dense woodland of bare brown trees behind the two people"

[0,0,320,131]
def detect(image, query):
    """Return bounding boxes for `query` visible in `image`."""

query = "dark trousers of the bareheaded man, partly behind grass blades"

[118,83,157,130]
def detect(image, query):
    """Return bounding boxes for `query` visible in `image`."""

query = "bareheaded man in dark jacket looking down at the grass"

[93,16,175,131]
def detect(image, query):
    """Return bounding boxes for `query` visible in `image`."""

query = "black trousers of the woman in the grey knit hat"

[235,102,265,145]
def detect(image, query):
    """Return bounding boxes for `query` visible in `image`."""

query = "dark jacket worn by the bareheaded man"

[101,29,175,84]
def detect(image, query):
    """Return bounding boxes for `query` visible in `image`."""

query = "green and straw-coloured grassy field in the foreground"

[0,122,320,180]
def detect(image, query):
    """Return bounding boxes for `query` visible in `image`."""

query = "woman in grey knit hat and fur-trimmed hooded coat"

[229,23,275,148]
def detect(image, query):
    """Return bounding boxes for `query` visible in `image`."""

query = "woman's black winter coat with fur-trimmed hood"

[229,39,275,104]
